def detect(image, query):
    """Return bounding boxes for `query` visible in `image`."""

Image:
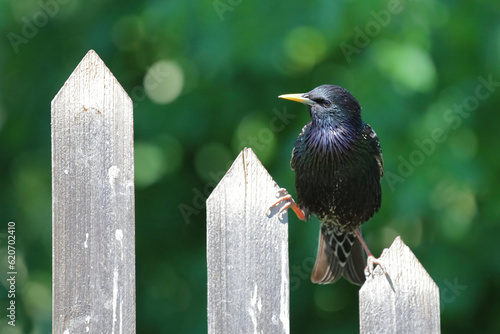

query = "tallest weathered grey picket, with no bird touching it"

[52,50,136,334]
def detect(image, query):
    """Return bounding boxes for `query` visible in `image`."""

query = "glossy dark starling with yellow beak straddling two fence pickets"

[273,85,383,285]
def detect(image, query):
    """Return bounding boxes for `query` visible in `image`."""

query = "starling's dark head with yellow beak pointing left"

[279,85,361,124]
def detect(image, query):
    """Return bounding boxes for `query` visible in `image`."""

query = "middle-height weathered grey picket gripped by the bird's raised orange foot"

[207,149,290,334]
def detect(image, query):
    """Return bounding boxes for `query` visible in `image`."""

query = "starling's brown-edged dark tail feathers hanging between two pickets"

[311,225,366,285]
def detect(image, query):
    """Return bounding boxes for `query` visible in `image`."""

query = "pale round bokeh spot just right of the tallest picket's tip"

[144,60,184,104]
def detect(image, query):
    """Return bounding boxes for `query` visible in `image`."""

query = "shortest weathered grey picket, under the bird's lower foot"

[359,237,440,334]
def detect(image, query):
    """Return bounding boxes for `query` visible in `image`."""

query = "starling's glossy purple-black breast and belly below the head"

[293,125,380,230]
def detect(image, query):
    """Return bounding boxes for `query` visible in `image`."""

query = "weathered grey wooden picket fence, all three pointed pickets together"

[52,50,440,334]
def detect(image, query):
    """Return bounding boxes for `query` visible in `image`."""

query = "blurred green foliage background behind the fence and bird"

[0,0,500,334]
